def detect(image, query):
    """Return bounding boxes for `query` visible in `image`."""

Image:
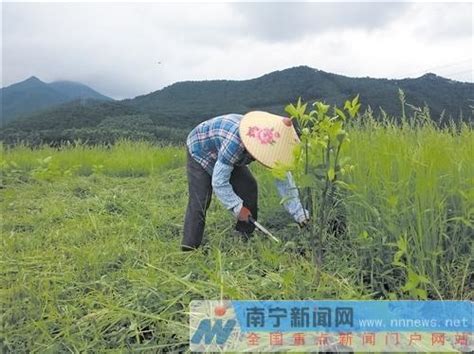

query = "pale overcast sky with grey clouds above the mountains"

[2,2,473,98]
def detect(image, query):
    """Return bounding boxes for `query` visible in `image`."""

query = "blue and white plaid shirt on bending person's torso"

[186,114,253,175]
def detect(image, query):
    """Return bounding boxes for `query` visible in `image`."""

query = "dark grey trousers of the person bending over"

[181,152,258,251]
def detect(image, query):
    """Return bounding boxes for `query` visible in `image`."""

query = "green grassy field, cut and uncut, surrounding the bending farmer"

[0,122,474,352]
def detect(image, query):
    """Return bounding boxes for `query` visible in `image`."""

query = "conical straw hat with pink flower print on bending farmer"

[239,111,300,168]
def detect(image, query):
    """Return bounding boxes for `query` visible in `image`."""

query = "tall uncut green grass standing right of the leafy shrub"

[347,115,474,298]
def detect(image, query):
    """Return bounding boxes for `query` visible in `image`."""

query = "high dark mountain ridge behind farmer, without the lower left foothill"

[123,66,474,127]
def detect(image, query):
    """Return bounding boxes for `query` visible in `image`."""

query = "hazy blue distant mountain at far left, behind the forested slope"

[0,76,112,122]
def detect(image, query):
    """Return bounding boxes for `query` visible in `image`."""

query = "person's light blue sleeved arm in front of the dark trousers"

[212,159,243,217]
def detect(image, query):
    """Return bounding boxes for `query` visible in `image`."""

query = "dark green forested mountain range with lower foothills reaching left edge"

[2,66,474,143]
